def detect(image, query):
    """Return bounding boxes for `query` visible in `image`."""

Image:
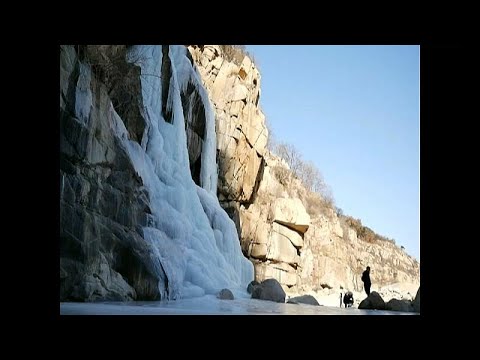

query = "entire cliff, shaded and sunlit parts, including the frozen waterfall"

[59,45,419,301]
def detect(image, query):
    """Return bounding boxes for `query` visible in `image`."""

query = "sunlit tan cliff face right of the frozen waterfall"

[189,45,419,292]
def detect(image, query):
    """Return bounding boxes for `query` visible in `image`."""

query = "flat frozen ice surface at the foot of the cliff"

[60,295,418,315]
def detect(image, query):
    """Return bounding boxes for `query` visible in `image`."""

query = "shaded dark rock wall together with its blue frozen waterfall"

[60,46,253,301]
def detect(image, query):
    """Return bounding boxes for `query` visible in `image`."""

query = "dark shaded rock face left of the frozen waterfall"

[60,46,164,301]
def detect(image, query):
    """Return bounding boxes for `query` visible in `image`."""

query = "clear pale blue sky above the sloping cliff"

[247,45,420,260]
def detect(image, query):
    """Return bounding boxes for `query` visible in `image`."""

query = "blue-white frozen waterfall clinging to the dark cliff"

[109,46,253,299]
